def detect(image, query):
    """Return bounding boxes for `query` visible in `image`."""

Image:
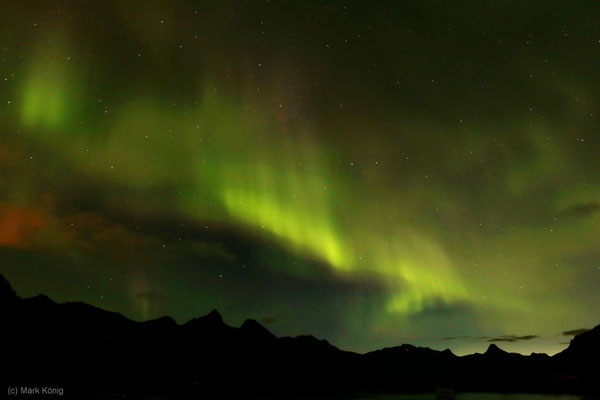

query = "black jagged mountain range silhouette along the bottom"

[0,275,600,399]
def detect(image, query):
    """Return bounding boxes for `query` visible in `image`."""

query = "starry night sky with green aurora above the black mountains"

[0,0,600,354]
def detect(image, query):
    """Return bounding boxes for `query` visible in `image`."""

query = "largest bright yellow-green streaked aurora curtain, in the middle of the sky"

[222,137,352,270]
